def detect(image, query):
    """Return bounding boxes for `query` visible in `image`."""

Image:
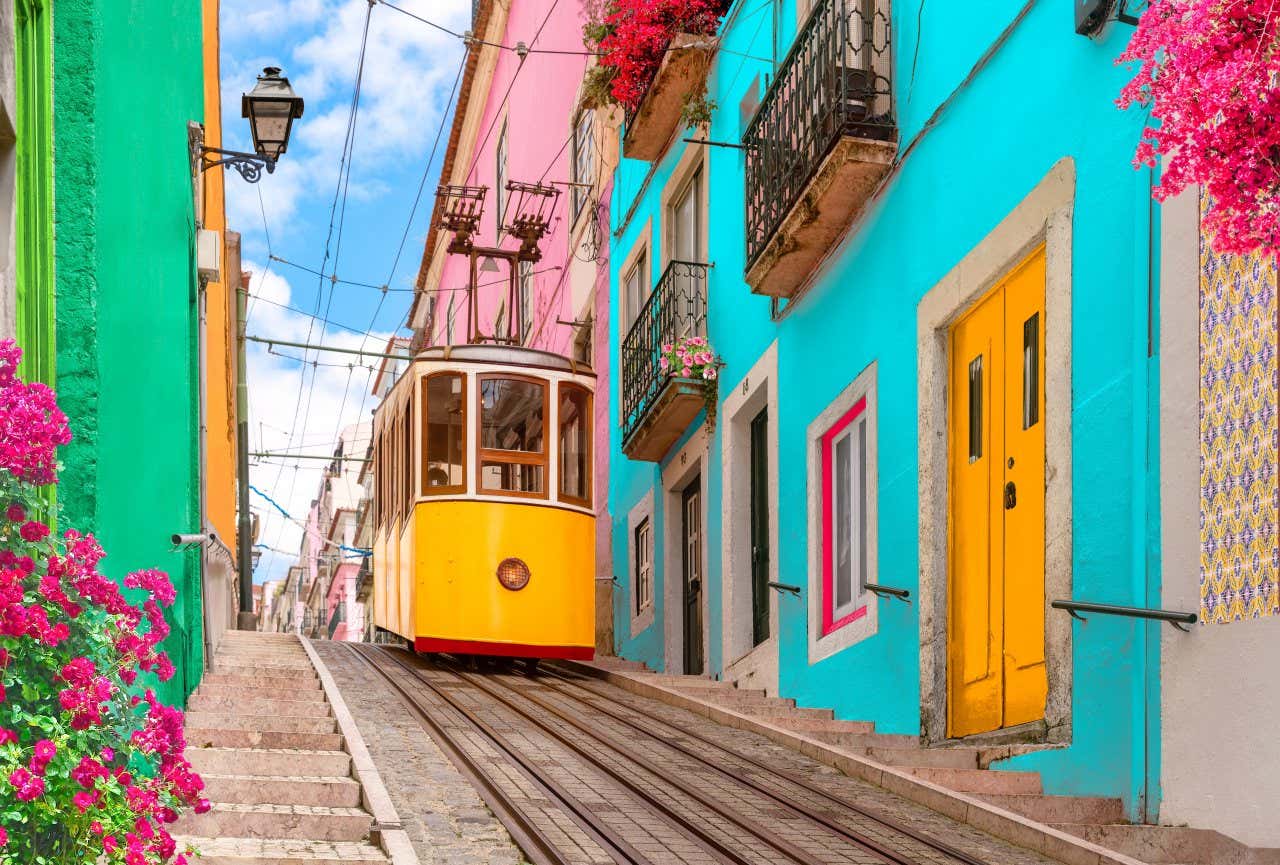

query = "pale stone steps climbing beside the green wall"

[177,631,388,865]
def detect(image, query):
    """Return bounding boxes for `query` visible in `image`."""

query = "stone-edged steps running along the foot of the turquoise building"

[578,656,1280,865]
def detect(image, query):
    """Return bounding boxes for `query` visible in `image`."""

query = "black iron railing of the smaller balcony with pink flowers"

[622,261,709,441]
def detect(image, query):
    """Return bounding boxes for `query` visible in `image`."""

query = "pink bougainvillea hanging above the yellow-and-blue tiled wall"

[1117,0,1280,253]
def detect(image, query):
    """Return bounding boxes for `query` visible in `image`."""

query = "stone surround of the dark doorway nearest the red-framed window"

[719,342,780,696]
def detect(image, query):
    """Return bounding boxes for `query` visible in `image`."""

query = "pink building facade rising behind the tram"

[410,0,621,653]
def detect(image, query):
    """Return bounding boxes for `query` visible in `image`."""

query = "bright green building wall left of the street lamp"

[52,0,204,704]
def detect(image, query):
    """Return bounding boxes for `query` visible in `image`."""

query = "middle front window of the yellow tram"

[480,376,547,496]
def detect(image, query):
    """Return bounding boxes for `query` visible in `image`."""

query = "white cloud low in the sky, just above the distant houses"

[246,264,390,582]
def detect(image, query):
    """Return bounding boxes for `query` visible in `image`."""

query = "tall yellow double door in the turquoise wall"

[947,248,1048,736]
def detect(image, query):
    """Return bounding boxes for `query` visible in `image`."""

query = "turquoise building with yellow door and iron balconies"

[609,0,1162,820]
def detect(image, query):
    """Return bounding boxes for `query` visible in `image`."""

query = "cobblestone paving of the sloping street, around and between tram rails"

[325,644,1075,865]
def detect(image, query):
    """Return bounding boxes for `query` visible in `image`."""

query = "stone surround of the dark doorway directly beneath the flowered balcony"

[654,426,712,674]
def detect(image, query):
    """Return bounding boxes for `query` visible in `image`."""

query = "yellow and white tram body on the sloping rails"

[372,344,595,659]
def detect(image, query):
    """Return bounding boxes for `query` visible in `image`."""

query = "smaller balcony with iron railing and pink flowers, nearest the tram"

[622,261,708,462]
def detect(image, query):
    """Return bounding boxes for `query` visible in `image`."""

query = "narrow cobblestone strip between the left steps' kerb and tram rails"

[312,640,525,865]
